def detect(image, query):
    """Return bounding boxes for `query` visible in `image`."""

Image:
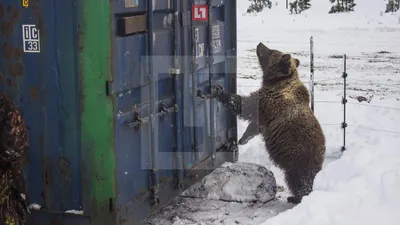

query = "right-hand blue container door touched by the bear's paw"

[182,0,236,172]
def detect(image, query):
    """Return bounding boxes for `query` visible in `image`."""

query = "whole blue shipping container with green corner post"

[0,0,237,225]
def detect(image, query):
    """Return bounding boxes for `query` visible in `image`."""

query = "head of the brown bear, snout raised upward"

[256,42,300,84]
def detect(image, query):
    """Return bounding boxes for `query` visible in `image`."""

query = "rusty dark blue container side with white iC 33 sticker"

[0,0,82,217]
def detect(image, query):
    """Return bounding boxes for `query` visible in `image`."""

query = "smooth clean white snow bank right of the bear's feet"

[262,146,400,225]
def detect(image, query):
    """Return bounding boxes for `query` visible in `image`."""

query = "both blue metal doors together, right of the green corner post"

[109,0,236,222]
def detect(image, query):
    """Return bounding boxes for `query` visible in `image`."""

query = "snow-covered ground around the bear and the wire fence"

[144,0,400,225]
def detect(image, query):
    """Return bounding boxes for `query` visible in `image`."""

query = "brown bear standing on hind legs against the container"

[216,43,325,204]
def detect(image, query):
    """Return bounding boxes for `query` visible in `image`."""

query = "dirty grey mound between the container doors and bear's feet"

[182,162,276,202]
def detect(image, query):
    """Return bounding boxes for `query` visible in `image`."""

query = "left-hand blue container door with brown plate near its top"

[108,0,183,222]
